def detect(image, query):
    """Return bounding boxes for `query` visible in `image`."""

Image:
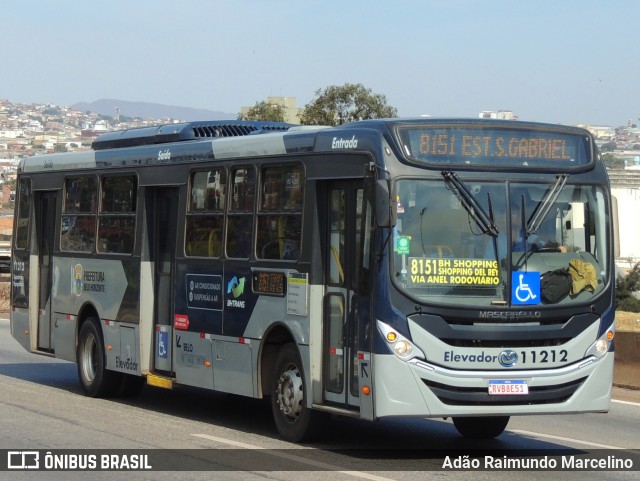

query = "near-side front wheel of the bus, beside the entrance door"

[271,343,328,443]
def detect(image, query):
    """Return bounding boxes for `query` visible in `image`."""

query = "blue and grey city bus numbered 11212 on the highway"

[11,118,615,441]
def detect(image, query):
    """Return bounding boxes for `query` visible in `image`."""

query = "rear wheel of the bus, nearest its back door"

[76,317,122,397]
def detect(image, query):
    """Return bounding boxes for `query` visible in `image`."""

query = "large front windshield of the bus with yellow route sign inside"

[393,179,609,306]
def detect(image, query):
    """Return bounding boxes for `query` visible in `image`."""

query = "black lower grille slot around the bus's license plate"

[423,377,587,406]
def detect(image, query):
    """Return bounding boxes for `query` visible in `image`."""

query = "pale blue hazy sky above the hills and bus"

[0,0,640,127]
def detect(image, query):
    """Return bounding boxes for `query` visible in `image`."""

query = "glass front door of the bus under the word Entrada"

[322,181,372,418]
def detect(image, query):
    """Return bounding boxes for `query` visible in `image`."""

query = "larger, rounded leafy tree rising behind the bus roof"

[300,83,398,125]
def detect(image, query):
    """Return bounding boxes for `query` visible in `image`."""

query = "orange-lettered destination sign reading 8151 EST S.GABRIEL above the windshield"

[400,126,590,166]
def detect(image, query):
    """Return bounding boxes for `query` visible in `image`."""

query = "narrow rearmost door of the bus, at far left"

[35,192,57,352]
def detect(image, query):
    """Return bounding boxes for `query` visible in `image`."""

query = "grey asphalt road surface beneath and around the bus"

[0,320,640,481]
